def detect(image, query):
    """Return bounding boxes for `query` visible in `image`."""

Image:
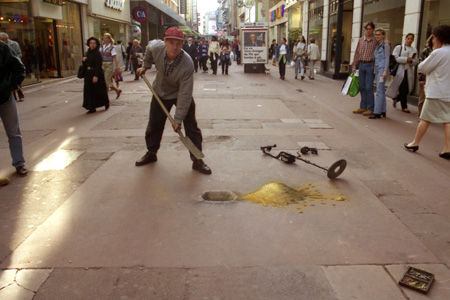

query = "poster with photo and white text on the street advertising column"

[242,29,267,64]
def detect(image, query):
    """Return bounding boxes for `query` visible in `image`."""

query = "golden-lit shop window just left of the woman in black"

[56,2,83,77]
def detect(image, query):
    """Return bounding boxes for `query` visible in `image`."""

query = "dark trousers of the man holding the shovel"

[145,97,203,161]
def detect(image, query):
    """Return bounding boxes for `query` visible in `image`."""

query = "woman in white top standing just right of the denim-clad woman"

[386,33,419,113]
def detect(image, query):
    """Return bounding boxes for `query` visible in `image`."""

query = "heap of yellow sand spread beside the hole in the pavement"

[239,182,346,213]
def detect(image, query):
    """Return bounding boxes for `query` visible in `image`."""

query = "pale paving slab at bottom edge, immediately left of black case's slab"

[323,266,406,300]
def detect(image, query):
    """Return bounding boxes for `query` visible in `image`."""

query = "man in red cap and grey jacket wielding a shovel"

[136,27,211,174]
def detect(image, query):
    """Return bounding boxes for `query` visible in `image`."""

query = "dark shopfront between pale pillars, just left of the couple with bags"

[326,0,353,78]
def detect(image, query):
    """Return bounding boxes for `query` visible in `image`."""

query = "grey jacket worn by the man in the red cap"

[144,40,194,124]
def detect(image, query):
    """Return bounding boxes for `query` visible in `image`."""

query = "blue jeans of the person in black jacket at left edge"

[0,94,25,167]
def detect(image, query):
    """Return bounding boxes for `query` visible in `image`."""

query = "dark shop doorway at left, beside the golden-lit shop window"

[34,18,59,78]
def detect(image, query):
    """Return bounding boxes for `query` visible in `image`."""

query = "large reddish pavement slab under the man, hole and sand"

[2,151,436,268]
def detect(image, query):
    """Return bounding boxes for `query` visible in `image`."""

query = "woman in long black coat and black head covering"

[83,37,109,114]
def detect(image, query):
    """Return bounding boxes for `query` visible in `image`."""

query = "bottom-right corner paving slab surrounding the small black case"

[386,264,450,300]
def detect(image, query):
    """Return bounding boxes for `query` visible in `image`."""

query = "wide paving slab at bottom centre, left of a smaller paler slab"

[186,266,337,300]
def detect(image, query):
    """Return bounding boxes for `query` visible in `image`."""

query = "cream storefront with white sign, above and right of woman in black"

[87,0,130,44]
